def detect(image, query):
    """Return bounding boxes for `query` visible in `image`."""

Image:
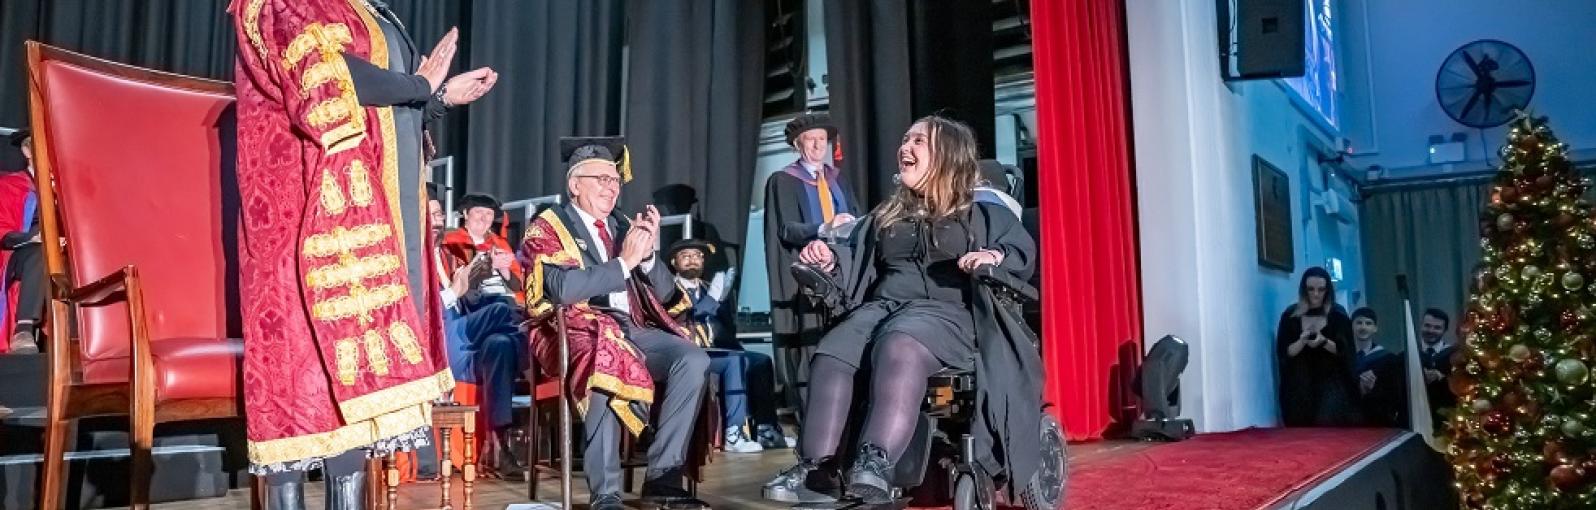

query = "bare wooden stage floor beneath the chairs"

[121,441,1152,510]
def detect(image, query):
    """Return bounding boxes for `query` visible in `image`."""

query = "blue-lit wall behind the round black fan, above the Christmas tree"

[1341,0,1596,177]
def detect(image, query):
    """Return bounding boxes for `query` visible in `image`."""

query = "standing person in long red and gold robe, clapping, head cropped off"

[230,0,496,508]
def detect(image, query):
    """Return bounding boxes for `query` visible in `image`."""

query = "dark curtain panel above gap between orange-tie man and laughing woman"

[825,0,915,206]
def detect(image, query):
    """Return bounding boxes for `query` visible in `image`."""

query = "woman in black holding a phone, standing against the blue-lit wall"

[1275,266,1361,427]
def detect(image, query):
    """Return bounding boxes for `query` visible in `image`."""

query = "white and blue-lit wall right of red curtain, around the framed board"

[1127,0,1363,432]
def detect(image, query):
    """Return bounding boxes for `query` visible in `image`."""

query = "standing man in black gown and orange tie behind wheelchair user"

[764,113,868,405]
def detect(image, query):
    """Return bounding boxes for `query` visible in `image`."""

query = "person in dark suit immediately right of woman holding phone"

[1352,308,1408,427]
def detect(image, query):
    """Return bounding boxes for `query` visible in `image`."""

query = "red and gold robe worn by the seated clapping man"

[520,209,688,434]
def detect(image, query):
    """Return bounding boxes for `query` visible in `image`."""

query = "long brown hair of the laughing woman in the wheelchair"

[873,115,982,228]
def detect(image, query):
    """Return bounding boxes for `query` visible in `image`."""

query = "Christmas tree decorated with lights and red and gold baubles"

[1455,116,1596,510]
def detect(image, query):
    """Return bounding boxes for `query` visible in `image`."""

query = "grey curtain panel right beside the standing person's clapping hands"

[456,0,626,201]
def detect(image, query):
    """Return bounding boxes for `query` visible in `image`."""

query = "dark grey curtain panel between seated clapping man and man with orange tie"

[622,0,764,251]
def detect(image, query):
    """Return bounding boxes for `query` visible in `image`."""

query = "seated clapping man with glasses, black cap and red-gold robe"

[520,137,709,510]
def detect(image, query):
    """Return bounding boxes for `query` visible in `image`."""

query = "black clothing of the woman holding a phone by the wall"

[1275,304,1361,427]
